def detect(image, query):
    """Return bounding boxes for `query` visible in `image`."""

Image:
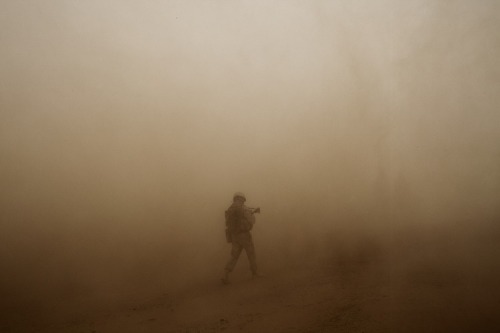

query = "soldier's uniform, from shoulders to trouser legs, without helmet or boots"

[226,203,257,275]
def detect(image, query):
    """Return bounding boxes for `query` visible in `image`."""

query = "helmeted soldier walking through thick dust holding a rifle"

[222,192,260,284]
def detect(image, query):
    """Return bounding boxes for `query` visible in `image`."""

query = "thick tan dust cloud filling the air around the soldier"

[0,0,500,328]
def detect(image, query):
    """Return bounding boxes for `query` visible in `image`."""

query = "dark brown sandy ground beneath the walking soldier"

[2,252,500,333]
